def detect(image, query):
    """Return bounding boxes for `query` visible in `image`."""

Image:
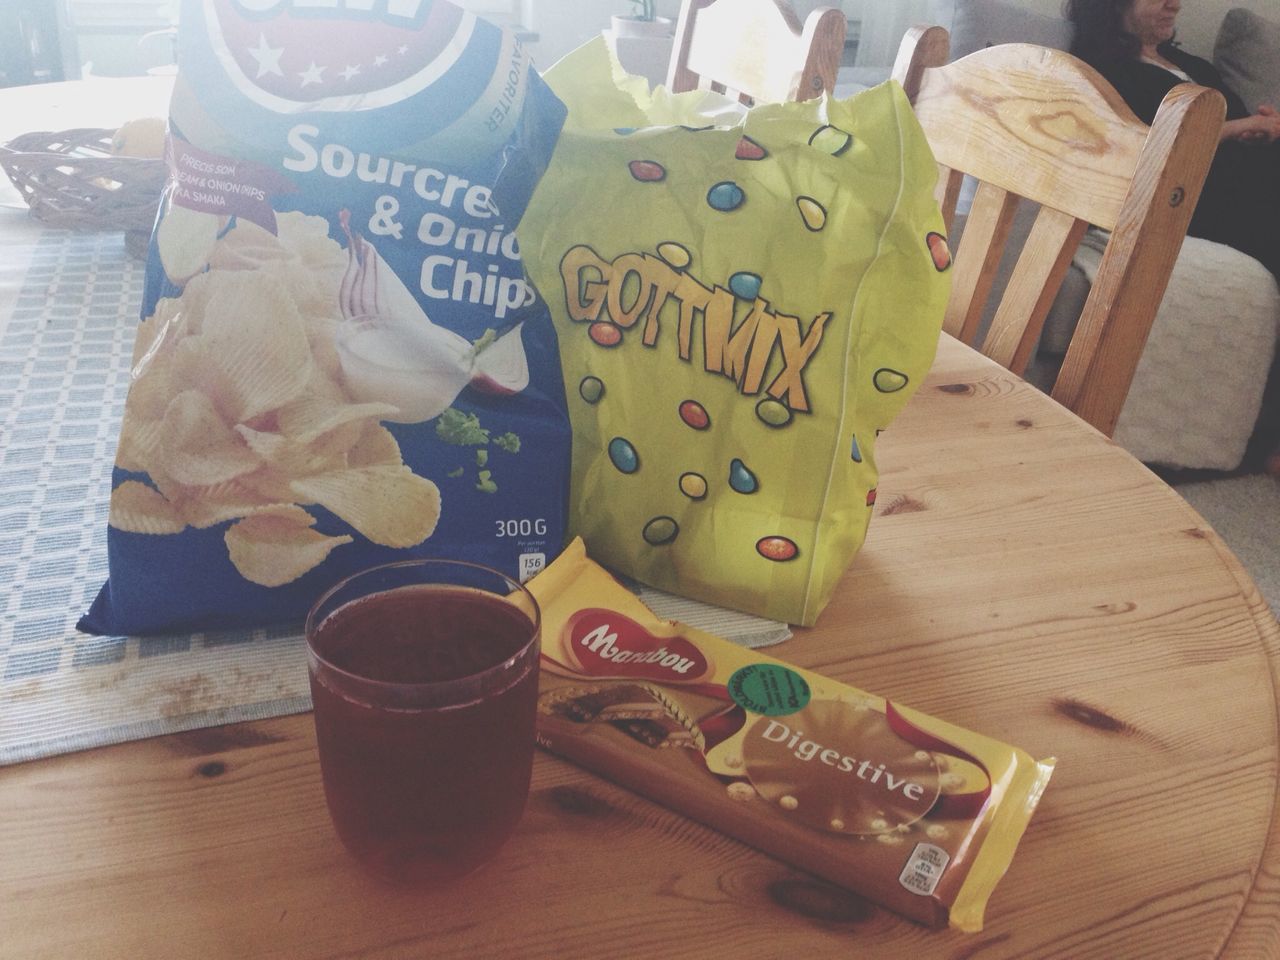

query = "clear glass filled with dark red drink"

[307,561,540,884]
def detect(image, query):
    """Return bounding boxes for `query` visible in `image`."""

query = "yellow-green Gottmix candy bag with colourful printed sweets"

[520,42,951,625]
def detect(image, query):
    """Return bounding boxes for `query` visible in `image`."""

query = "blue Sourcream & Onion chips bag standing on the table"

[79,0,570,634]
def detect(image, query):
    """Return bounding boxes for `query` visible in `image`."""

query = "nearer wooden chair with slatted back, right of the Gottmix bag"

[893,27,1225,436]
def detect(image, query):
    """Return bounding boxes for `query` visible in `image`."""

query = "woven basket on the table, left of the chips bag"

[0,129,166,232]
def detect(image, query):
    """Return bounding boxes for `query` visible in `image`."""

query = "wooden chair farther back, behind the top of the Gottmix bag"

[667,0,847,105]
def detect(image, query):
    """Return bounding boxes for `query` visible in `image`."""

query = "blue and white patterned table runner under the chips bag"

[0,230,790,764]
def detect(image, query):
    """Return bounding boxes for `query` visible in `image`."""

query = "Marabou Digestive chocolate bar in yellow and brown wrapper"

[529,540,1055,932]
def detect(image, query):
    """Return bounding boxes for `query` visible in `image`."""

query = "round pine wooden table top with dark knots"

[0,338,1280,960]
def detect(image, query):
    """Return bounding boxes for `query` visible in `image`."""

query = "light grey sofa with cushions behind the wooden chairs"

[836,0,1280,471]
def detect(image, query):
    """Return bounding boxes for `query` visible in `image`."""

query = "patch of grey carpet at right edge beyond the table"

[1174,474,1280,617]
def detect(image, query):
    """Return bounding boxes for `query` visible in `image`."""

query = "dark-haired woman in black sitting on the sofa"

[1066,0,1280,476]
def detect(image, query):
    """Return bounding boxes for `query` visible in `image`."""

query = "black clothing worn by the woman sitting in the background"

[1093,44,1280,282]
